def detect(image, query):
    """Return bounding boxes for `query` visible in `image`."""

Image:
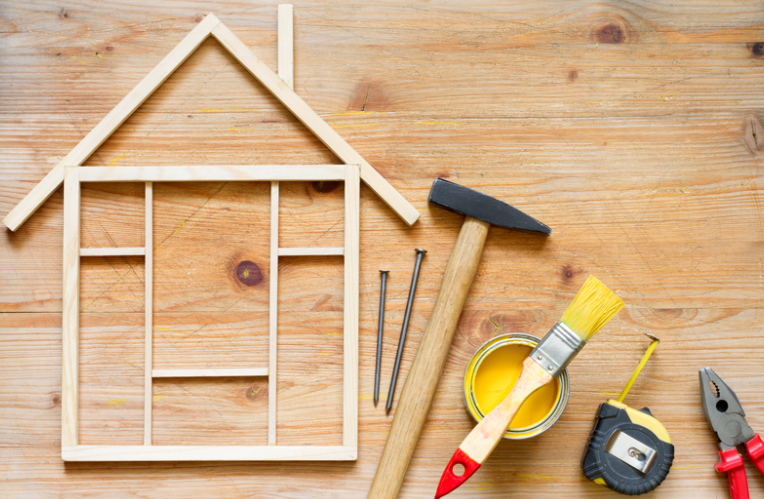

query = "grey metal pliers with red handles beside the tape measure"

[700,367,764,499]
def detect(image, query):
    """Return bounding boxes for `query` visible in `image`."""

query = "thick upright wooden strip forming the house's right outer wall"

[342,165,361,447]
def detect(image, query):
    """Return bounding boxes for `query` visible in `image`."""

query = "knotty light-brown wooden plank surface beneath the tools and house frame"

[0,0,764,499]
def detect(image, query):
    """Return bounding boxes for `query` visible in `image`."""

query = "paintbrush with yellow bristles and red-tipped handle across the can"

[435,276,623,499]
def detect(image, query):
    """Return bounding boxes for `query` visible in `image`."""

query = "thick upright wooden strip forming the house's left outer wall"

[61,167,80,446]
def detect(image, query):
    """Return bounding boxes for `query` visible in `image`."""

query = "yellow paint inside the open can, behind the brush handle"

[472,345,560,429]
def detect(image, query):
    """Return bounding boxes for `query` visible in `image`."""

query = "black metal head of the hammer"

[428,178,552,235]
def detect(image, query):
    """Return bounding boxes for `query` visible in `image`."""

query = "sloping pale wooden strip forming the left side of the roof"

[3,14,220,231]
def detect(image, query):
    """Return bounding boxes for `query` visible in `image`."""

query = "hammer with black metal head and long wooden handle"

[367,178,552,499]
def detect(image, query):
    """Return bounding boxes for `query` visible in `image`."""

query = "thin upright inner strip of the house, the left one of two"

[143,182,154,445]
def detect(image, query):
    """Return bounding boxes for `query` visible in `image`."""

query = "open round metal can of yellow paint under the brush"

[464,333,570,440]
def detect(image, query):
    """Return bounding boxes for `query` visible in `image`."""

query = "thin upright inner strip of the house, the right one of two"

[268,181,280,445]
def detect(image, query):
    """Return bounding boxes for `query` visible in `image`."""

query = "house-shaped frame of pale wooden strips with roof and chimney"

[3,5,419,461]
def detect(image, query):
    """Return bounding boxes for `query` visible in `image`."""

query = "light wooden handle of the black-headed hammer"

[367,217,491,499]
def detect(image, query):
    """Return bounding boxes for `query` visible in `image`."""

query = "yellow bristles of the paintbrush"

[560,276,624,341]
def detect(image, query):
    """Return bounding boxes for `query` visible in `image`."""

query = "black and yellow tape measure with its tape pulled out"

[581,335,674,496]
